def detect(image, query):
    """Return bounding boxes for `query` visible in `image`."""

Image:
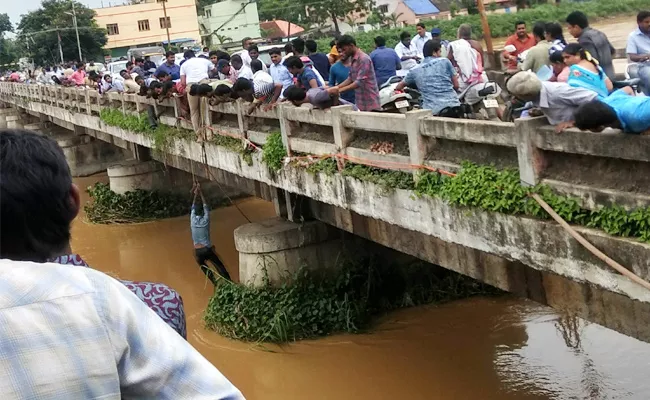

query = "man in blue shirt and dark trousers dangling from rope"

[190,182,231,284]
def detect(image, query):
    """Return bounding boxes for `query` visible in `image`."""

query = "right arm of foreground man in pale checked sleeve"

[92,269,244,399]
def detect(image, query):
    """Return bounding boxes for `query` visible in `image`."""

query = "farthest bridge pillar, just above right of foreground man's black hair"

[53,134,130,176]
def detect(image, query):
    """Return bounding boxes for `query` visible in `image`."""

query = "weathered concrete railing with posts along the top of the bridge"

[0,82,650,208]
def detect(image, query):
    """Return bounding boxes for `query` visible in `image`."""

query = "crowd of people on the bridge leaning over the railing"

[5,11,650,137]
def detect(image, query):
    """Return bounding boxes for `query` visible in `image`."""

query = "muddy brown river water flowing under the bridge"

[72,176,650,400]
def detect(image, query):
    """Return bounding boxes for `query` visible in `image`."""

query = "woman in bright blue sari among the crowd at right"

[562,43,614,98]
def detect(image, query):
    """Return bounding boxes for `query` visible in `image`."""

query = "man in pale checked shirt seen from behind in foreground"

[0,130,243,400]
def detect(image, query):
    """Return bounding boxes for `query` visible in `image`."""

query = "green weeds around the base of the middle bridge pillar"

[84,183,225,224]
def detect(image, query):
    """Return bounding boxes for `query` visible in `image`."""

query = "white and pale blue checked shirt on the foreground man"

[0,260,243,400]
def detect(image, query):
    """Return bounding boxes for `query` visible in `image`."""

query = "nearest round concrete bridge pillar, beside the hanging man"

[234,217,342,286]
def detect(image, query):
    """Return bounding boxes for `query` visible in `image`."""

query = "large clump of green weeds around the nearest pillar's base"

[204,255,500,343]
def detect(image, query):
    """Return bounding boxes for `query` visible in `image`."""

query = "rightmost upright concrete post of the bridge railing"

[515,117,547,186]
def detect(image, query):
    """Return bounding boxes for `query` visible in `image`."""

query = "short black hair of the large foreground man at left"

[0,130,77,262]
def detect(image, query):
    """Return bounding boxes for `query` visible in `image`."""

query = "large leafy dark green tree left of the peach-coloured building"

[18,0,107,65]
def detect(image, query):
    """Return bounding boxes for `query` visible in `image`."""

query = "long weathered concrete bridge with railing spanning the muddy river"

[0,83,650,341]
